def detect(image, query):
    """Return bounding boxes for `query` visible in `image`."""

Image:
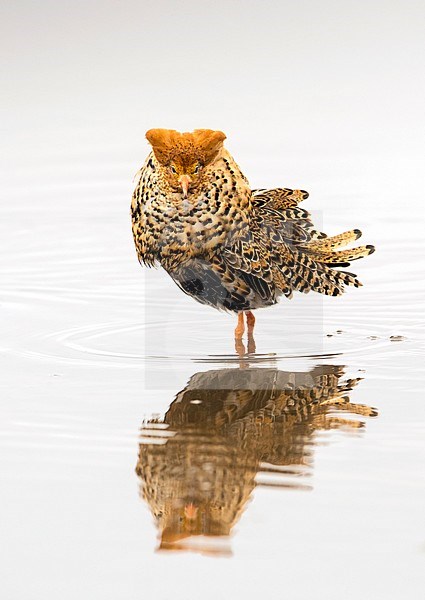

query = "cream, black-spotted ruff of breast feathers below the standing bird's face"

[132,152,251,261]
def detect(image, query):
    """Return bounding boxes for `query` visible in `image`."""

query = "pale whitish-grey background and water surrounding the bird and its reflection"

[0,0,425,600]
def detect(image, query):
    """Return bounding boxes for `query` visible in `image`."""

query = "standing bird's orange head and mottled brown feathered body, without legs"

[131,129,374,332]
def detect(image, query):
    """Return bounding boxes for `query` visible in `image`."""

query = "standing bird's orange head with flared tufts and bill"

[146,129,226,198]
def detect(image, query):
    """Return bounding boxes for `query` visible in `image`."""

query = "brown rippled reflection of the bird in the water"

[136,365,377,554]
